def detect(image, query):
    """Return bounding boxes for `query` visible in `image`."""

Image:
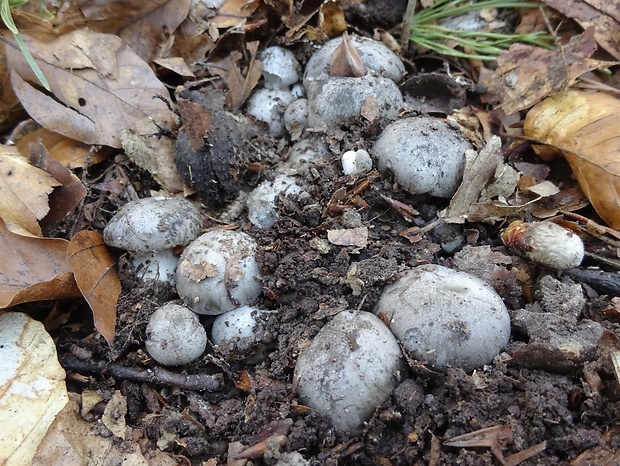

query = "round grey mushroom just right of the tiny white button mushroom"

[371,117,471,198]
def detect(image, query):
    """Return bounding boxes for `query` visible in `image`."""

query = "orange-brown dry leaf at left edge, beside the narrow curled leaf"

[0,218,81,308]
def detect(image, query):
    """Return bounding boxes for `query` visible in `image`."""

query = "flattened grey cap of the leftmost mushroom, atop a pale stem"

[103,197,202,252]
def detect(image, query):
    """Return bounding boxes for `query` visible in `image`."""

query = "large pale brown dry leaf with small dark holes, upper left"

[7,30,176,148]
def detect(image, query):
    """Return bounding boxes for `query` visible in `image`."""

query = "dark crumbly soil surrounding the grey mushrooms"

[26,2,620,466]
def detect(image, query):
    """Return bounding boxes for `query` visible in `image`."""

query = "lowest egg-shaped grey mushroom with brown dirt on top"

[294,311,406,435]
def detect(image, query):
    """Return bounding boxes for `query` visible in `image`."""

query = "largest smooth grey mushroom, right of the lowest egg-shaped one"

[374,265,510,371]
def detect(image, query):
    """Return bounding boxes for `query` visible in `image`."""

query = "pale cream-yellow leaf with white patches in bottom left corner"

[0,312,69,465]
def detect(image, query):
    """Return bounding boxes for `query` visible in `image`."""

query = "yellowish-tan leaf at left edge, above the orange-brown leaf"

[0,146,60,236]
